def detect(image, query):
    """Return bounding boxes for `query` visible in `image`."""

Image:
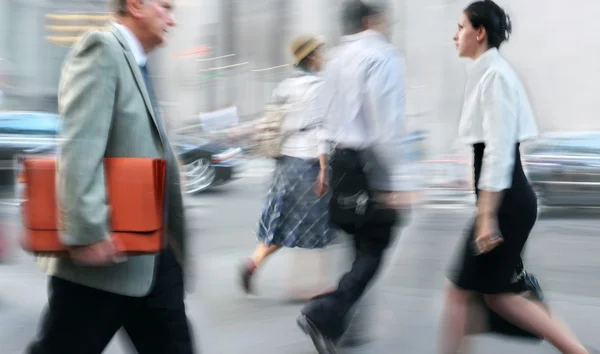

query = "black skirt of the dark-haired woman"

[449,143,537,294]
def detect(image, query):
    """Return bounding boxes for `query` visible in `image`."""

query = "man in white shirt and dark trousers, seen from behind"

[298,0,408,353]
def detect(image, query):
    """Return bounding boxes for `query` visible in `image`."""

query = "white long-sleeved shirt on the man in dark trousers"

[321,30,410,191]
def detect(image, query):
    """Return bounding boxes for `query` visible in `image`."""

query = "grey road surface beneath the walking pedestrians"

[0,160,600,354]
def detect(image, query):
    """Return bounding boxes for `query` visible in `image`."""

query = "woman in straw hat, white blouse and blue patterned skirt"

[240,34,335,293]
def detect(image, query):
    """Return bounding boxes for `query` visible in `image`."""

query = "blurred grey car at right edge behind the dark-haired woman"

[523,132,600,207]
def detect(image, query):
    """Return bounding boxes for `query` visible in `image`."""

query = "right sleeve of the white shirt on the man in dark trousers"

[365,50,410,191]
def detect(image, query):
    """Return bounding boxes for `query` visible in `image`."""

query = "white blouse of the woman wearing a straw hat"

[273,70,329,160]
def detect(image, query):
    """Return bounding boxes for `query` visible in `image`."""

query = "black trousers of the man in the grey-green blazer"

[27,251,195,354]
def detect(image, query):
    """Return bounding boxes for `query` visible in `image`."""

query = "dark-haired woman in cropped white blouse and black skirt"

[440,0,588,354]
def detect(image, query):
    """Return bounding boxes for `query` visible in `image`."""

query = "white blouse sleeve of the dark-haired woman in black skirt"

[478,73,518,192]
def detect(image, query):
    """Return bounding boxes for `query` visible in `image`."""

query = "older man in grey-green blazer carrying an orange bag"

[29,0,194,354]
